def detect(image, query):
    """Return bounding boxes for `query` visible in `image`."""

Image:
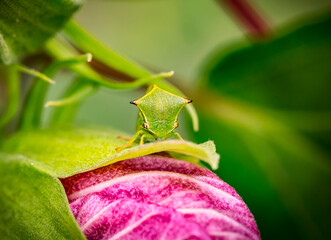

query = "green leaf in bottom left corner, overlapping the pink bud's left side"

[0,153,85,239]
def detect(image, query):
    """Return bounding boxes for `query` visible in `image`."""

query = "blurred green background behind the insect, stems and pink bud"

[3,0,331,239]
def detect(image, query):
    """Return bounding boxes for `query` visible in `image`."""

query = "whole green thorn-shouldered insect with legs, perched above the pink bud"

[116,85,192,151]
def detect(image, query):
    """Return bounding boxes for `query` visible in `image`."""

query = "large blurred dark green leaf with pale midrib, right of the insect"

[195,13,331,239]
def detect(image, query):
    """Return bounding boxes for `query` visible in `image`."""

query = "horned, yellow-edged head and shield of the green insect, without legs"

[130,85,192,139]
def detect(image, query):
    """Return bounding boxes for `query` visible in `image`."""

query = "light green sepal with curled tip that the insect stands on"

[3,128,219,178]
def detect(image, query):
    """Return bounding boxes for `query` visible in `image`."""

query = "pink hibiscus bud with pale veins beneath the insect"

[61,156,260,240]
